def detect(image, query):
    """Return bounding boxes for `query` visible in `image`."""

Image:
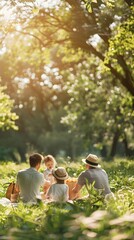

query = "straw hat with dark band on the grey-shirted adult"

[82,154,101,168]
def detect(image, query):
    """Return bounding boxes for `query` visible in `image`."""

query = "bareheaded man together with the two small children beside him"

[16,153,69,203]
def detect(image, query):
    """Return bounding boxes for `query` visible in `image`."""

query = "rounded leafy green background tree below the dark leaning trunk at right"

[62,58,134,157]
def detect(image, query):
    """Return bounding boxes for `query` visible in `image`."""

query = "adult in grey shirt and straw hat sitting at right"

[73,154,111,197]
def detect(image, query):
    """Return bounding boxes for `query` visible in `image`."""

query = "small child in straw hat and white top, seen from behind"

[47,167,69,202]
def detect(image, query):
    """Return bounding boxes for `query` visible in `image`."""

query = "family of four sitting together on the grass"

[11,153,113,203]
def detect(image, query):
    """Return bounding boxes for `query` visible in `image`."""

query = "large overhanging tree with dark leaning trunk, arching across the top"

[2,0,134,95]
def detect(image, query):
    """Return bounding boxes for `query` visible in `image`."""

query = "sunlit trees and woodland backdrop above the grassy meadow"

[0,0,134,162]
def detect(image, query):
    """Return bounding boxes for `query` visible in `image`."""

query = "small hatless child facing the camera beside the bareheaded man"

[43,155,56,184]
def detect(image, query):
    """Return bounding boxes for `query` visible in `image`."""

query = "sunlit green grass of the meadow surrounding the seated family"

[0,159,134,240]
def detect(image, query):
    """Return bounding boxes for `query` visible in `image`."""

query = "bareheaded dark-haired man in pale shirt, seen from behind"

[16,153,50,203]
